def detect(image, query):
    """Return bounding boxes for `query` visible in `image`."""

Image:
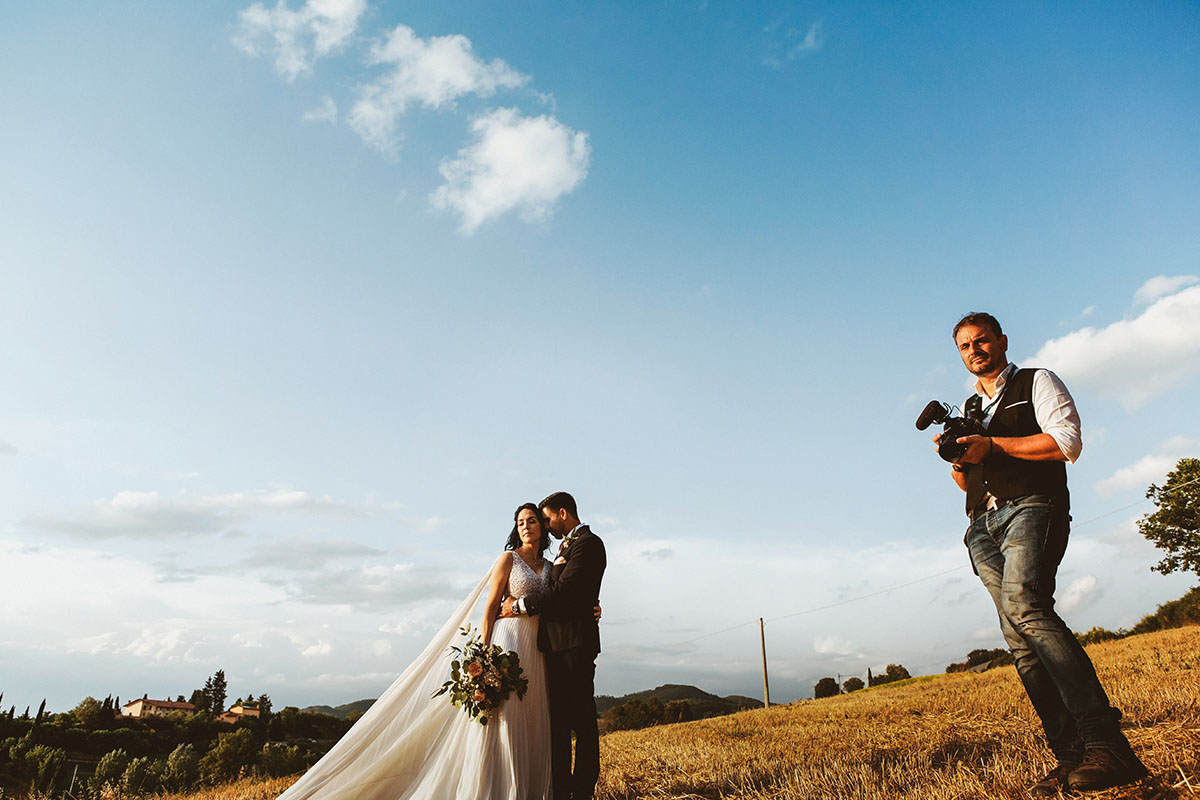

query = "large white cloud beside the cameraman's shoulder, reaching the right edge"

[1028,287,1200,409]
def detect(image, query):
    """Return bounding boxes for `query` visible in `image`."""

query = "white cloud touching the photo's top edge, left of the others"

[233,0,367,82]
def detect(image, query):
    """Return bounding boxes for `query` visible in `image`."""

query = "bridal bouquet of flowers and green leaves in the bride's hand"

[433,625,529,724]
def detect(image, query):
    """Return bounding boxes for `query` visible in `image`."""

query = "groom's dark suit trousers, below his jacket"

[546,648,600,800]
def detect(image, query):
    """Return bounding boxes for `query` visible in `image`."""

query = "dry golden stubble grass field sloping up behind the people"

[162,627,1200,800]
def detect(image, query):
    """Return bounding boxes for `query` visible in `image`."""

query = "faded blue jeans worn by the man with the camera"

[964,494,1128,762]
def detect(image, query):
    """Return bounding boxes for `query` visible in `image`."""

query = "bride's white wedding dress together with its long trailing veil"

[278,553,550,800]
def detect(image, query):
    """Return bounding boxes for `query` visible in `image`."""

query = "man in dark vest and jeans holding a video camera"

[935,313,1146,795]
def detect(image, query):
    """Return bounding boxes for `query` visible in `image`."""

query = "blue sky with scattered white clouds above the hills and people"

[0,0,1200,710]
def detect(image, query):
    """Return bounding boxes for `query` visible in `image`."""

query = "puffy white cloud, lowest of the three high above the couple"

[430,108,589,234]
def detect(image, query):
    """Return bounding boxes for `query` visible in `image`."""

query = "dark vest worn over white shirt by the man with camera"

[964,369,1070,517]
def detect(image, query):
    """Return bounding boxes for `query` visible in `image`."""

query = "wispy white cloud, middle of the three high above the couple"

[350,25,529,156]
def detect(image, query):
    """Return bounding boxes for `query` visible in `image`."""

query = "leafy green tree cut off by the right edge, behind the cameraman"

[1138,458,1200,575]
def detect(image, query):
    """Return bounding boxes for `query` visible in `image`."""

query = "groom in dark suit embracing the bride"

[500,492,606,800]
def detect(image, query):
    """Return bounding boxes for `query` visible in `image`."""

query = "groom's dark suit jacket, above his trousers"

[524,525,607,652]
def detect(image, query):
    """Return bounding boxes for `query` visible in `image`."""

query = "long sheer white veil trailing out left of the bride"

[278,577,508,800]
